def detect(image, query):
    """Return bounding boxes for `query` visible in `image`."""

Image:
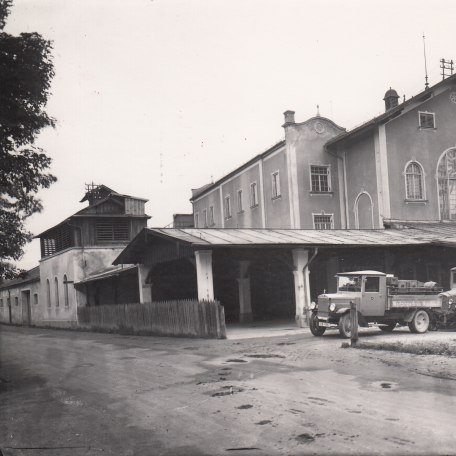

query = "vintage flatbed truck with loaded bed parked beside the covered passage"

[309,271,456,338]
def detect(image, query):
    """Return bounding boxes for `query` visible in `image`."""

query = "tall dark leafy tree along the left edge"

[0,0,56,281]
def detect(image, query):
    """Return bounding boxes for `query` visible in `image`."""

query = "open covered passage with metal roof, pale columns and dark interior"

[114,228,456,326]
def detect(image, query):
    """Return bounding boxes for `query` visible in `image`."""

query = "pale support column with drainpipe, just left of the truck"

[292,249,310,328]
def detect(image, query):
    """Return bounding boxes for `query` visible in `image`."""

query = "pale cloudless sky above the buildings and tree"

[5,0,456,268]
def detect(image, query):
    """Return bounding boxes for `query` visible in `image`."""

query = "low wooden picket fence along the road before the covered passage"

[78,300,226,339]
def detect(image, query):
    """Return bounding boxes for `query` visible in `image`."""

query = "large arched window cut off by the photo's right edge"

[437,149,456,220]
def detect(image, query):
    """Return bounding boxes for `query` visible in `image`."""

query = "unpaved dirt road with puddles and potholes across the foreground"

[0,326,456,456]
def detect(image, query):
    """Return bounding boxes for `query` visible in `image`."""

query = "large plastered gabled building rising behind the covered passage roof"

[191,75,456,233]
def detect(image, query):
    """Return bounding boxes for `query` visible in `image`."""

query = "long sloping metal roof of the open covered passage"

[113,223,456,264]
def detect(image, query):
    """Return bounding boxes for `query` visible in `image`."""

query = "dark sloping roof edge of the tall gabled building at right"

[325,74,456,148]
